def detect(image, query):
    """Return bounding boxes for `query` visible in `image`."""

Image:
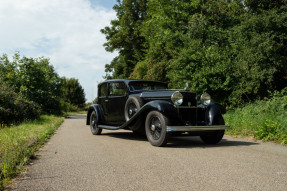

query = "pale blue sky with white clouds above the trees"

[0,0,117,102]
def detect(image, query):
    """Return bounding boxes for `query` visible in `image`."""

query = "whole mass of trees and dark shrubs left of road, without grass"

[0,53,86,125]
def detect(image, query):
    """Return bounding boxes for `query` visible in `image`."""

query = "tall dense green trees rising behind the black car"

[102,0,287,106]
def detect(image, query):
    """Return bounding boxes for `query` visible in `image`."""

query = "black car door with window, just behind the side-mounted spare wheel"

[106,82,127,125]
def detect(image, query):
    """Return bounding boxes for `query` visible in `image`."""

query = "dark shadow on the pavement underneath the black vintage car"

[102,131,259,148]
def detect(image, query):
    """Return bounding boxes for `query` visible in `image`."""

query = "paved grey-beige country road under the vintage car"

[7,115,287,191]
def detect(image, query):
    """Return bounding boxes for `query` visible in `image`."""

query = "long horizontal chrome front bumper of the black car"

[166,125,230,132]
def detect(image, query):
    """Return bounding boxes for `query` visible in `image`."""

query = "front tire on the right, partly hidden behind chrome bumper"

[200,115,225,144]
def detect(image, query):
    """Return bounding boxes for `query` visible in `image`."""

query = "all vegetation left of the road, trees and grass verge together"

[0,53,86,190]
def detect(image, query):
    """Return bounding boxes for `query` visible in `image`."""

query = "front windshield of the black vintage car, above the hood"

[129,81,167,91]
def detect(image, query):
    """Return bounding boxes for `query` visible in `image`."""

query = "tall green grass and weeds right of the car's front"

[224,89,287,145]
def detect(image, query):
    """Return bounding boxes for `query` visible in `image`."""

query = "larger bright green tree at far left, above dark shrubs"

[0,53,61,113]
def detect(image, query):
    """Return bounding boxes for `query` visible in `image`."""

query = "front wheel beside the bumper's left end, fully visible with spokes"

[145,111,169,147]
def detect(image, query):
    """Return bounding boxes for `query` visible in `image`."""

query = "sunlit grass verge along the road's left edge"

[0,115,64,190]
